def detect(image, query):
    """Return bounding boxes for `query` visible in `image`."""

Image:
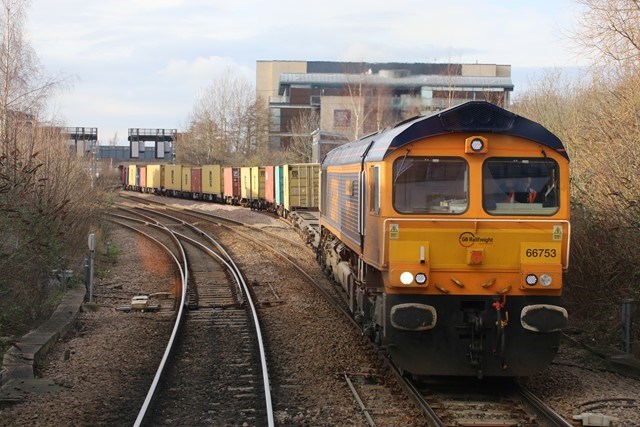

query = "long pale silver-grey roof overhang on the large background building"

[280,73,513,90]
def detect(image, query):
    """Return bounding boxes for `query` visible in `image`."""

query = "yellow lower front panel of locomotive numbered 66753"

[387,221,562,294]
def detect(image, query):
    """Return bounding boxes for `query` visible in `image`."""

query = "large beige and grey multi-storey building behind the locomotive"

[256,61,513,150]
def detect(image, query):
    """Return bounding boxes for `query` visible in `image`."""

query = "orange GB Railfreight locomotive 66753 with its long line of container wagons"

[123,101,571,377]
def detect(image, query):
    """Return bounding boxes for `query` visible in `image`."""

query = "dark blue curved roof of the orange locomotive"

[322,101,569,167]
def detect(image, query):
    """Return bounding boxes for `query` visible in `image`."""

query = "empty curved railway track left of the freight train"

[109,203,274,425]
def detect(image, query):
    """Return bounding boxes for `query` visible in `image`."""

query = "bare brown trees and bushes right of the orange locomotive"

[514,0,640,355]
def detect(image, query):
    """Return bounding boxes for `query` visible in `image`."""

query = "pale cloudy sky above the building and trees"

[26,0,581,144]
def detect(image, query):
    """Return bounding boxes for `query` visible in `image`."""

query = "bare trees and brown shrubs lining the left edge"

[0,0,111,360]
